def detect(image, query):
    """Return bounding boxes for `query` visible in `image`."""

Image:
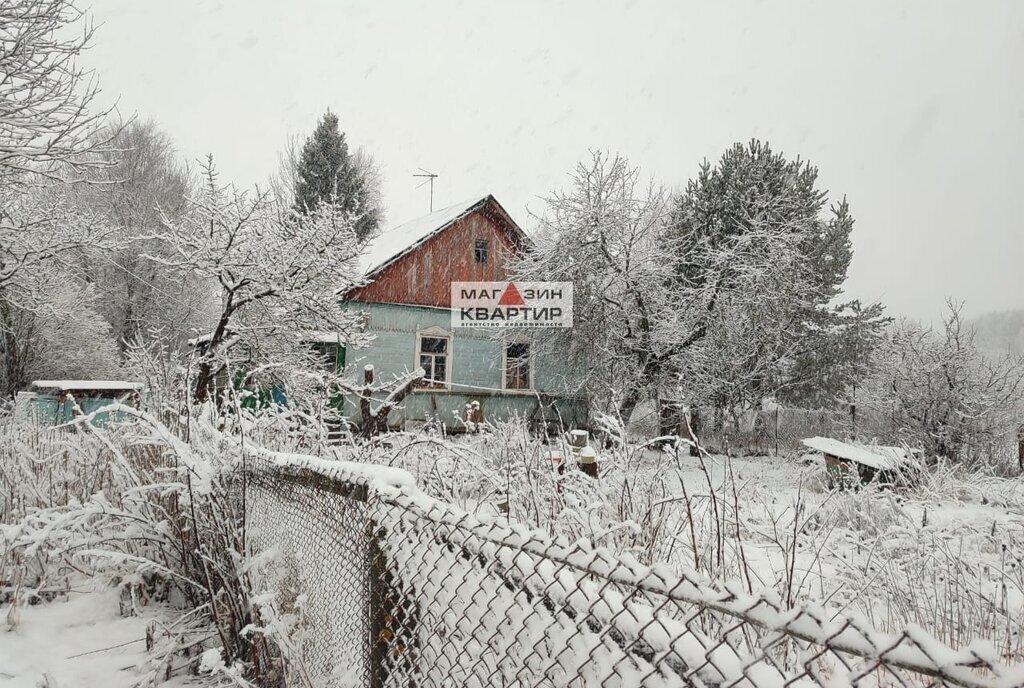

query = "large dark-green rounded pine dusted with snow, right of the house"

[668,140,885,407]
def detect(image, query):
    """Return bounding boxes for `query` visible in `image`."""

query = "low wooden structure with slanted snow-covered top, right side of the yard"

[803,437,919,487]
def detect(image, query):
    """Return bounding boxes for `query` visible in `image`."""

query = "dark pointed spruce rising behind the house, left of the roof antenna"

[295,110,380,240]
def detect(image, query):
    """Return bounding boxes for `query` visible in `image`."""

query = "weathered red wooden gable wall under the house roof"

[348,201,521,308]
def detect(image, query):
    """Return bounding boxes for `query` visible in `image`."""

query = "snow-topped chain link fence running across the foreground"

[244,454,1024,688]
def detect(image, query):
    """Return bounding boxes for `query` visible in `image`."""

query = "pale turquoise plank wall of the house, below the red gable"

[344,302,588,429]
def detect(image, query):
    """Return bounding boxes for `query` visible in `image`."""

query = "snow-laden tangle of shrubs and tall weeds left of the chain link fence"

[3,407,305,686]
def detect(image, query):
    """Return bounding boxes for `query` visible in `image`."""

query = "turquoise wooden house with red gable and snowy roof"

[343,196,588,431]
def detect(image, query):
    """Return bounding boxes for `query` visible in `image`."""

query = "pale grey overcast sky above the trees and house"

[85,0,1024,319]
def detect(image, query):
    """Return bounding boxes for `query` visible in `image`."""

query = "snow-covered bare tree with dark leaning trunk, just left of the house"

[146,162,365,401]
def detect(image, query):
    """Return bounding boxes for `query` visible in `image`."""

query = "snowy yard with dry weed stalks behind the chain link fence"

[362,429,1024,662]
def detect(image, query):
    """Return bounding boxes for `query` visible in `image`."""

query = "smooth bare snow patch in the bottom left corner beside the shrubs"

[0,584,175,688]
